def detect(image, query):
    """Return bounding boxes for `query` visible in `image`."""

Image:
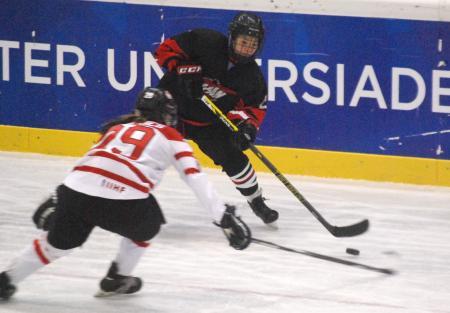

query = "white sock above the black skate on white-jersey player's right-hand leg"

[115,238,150,276]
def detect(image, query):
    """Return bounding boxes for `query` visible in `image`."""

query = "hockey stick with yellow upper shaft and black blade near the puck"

[201,95,369,237]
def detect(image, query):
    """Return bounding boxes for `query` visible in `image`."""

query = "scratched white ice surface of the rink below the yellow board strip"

[0,152,450,313]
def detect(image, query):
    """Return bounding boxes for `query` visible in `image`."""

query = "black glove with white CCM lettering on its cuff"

[176,61,203,99]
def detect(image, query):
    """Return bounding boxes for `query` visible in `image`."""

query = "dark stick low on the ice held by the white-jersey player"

[252,238,396,275]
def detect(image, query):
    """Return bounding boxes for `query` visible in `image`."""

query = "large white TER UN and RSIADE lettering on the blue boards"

[0,40,450,114]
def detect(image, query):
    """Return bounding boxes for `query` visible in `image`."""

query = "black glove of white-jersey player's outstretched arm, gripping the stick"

[216,204,252,250]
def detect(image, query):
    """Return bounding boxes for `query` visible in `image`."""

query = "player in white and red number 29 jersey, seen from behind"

[0,87,251,300]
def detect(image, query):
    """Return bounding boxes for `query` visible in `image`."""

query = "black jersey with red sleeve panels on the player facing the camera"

[155,29,267,126]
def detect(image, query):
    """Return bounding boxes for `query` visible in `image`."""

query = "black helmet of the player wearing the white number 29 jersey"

[135,87,177,127]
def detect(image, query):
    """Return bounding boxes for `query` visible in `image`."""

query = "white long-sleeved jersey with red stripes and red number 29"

[64,121,225,222]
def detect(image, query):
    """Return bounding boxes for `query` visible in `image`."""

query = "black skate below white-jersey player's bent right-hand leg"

[95,262,142,297]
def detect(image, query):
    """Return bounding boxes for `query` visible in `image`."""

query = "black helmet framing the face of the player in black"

[228,12,264,63]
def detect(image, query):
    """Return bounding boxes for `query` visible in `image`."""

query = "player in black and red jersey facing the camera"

[155,13,278,225]
